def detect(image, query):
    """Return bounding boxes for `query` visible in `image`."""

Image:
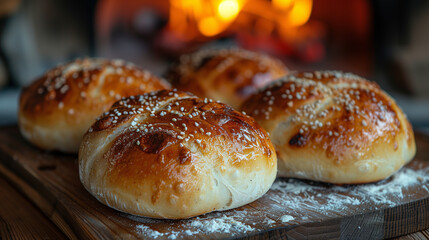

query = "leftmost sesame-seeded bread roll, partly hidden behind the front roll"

[18,59,169,153]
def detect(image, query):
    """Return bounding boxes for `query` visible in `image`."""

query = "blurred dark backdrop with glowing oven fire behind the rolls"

[0,0,429,132]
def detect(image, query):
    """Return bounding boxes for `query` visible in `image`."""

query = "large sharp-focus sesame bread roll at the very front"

[79,90,277,219]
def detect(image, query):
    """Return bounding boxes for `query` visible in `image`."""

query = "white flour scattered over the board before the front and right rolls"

[129,168,429,239]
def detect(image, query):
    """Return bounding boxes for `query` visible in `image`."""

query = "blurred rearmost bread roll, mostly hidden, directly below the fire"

[166,48,287,109]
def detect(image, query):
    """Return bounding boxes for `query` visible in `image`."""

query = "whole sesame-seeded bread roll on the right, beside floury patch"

[242,71,416,184]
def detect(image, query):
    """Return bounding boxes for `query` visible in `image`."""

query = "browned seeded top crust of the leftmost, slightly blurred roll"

[20,58,169,116]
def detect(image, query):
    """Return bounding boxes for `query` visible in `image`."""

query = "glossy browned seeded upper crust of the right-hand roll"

[242,71,415,173]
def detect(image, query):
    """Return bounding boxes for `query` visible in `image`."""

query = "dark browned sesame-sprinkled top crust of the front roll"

[89,90,272,163]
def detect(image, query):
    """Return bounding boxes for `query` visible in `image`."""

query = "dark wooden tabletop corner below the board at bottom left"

[0,173,66,240]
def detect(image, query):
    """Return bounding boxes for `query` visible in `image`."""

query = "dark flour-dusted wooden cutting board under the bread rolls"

[0,127,429,239]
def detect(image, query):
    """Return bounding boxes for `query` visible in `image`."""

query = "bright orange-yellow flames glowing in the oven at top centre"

[168,0,313,40]
